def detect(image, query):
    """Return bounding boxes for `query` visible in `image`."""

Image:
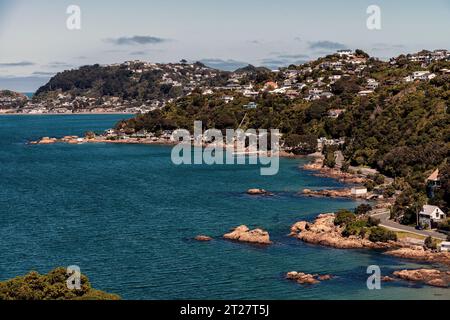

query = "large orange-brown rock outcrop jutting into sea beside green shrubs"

[290,214,393,249]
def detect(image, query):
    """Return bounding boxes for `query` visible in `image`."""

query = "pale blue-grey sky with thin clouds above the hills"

[0,0,450,91]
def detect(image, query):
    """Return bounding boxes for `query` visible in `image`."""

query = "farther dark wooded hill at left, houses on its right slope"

[35,61,229,101]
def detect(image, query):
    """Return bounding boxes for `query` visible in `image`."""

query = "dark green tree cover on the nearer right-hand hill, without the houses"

[118,57,450,215]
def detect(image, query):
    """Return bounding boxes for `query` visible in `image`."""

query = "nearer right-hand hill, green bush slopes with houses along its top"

[118,51,450,202]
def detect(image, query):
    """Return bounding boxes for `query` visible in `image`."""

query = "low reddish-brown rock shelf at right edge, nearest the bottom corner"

[394,269,450,288]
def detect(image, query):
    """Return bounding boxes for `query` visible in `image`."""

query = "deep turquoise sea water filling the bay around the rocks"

[0,115,450,300]
